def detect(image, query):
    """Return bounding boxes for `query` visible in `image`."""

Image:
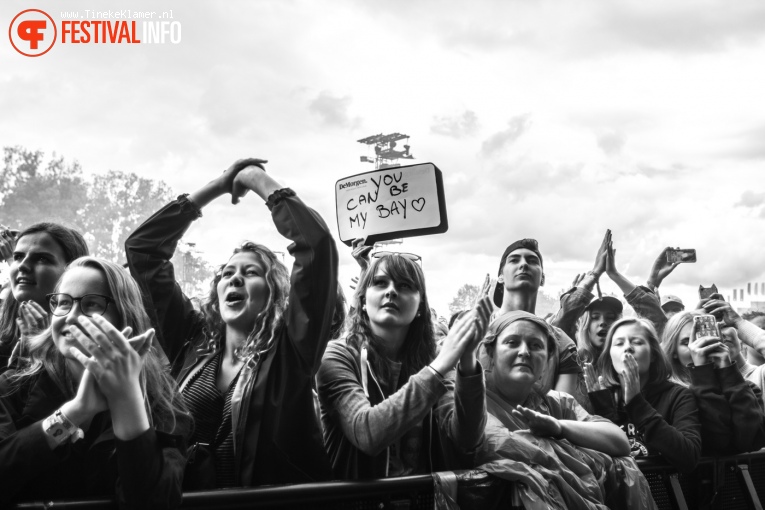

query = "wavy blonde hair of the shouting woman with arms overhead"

[200,241,290,361]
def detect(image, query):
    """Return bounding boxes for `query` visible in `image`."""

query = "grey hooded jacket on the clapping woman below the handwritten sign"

[317,340,486,480]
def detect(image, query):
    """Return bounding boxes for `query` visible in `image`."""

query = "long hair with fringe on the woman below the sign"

[346,254,436,379]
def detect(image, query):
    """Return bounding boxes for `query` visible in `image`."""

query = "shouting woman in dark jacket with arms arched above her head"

[125,159,337,489]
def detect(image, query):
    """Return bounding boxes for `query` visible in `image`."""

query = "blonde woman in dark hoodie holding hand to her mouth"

[589,318,701,472]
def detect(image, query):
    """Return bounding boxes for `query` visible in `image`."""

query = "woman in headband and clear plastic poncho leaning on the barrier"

[478,311,654,509]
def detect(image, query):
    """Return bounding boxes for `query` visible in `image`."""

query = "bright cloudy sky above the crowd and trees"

[0,0,765,314]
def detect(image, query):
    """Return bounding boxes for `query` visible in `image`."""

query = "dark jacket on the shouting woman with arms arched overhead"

[125,189,338,486]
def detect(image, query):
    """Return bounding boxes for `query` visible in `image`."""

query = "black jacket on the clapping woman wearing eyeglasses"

[0,371,186,509]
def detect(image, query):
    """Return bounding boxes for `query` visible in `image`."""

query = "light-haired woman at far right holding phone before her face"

[661,311,765,455]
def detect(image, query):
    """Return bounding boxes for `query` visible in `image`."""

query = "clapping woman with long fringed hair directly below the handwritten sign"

[317,254,491,480]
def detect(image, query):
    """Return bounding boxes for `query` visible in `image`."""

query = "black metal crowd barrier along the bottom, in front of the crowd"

[10,450,765,510]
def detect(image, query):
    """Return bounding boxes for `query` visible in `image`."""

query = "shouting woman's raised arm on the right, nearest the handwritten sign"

[234,166,338,376]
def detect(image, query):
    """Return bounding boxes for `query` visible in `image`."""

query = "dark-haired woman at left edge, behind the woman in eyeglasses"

[0,223,88,373]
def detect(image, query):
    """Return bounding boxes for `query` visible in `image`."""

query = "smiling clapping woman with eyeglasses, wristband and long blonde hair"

[0,257,191,508]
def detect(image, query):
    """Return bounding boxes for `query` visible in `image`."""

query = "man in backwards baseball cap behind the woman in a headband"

[494,239,589,407]
